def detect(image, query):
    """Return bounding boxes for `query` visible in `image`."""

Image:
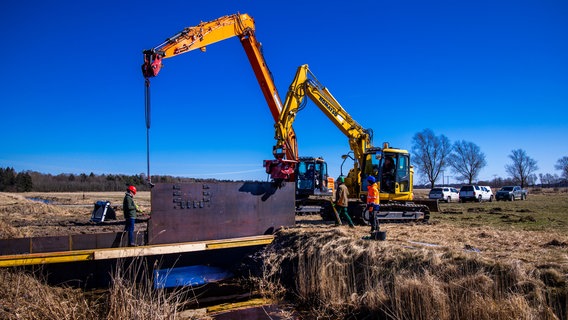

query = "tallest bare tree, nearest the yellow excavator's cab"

[412,129,452,188]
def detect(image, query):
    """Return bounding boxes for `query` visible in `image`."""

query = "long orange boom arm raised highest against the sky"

[142,13,298,159]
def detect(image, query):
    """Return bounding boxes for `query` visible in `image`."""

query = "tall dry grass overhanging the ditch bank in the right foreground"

[263,229,568,320]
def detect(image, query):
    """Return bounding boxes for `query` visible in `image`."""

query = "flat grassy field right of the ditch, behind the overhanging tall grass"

[296,190,568,268]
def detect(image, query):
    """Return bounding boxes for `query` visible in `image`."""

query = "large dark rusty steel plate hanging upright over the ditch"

[148,181,295,244]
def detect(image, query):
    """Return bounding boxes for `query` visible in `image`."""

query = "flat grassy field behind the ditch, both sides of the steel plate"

[0,190,568,273]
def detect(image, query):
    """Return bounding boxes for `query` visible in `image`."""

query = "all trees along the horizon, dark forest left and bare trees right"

[0,133,568,192]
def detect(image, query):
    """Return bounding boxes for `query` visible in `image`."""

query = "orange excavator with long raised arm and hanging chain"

[142,13,333,205]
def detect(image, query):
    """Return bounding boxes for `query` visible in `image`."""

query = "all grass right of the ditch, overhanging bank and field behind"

[259,191,568,319]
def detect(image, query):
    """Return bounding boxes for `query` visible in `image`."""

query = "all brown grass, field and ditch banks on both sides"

[0,189,568,319]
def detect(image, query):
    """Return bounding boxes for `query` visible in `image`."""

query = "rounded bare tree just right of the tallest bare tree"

[448,140,487,184]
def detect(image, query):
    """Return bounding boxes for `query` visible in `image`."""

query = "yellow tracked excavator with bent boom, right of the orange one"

[267,65,430,223]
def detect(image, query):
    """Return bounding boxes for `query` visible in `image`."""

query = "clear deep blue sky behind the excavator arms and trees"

[0,0,568,181]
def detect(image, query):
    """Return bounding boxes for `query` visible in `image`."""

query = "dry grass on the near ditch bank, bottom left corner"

[0,259,194,320]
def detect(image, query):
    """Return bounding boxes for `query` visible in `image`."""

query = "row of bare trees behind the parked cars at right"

[412,129,568,188]
